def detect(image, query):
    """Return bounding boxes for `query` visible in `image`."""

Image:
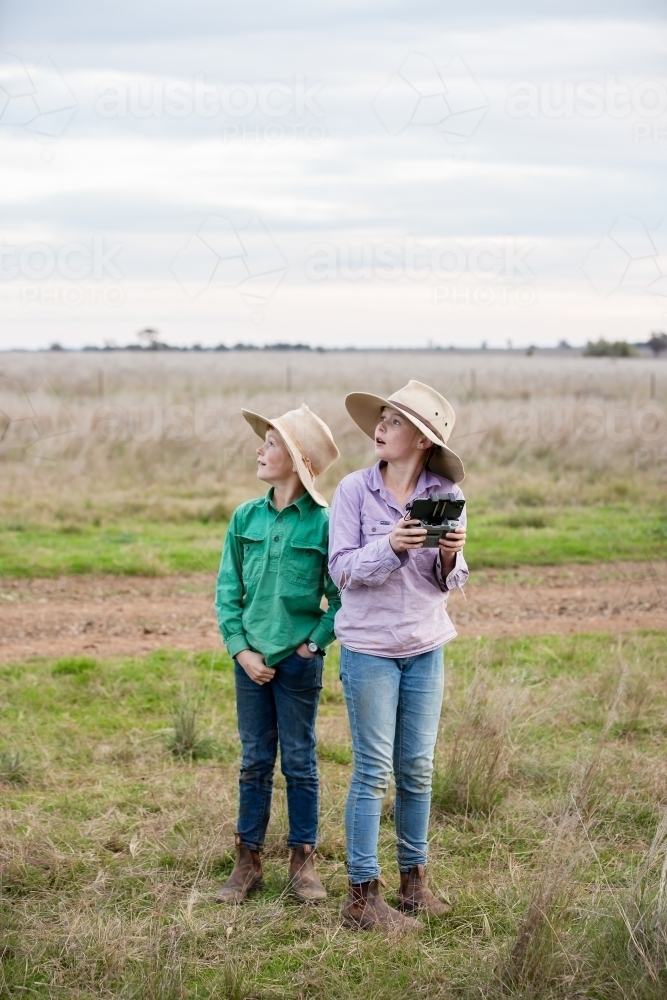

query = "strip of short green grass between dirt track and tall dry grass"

[0,503,667,577]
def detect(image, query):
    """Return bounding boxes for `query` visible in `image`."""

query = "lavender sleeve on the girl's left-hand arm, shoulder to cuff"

[329,484,408,590]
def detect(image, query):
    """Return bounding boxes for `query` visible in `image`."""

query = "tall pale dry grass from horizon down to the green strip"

[0,351,667,514]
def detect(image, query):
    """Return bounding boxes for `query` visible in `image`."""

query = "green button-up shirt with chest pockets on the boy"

[215,489,340,667]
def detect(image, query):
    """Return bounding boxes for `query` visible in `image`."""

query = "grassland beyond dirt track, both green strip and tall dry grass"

[0,351,667,575]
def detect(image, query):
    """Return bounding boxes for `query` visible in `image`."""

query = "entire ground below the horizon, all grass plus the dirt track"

[0,351,667,1000]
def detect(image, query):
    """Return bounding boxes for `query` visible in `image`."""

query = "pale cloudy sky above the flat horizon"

[0,0,667,349]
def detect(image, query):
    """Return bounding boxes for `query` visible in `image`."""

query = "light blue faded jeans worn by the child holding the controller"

[340,646,445,884]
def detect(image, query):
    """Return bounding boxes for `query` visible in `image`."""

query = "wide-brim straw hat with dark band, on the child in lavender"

[345,379,465,483]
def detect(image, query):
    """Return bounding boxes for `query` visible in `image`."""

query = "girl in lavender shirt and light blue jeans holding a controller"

[329,381,468,930]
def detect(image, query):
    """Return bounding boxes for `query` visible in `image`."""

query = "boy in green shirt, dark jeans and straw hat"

[215,403,340,903]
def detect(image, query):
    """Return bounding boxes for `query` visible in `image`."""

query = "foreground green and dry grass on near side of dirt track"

[0,633,667,1000]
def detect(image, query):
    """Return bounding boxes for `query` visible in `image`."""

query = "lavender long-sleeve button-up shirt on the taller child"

[329,462,468,658]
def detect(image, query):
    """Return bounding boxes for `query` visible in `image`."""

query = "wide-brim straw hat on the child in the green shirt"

[241,403,340,507]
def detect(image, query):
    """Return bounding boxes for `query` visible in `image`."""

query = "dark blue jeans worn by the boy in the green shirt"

[234,653,323,851]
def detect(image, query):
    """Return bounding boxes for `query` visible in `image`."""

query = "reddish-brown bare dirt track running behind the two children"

[0,562,667,662]
